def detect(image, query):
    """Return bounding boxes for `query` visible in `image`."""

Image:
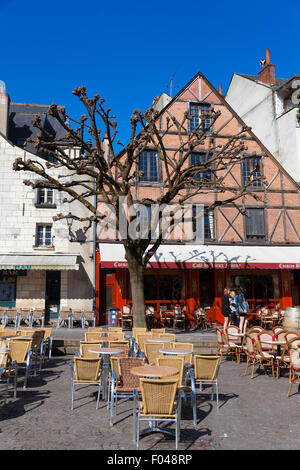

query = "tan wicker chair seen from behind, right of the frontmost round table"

[190,355,221,426]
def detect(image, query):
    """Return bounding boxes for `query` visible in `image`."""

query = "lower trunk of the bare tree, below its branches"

[126,250,146,328]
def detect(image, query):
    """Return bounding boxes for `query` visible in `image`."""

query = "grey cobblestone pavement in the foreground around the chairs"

[0,356,300,451]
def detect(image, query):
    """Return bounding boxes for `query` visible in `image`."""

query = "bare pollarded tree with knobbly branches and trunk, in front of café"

[14,86,261,326]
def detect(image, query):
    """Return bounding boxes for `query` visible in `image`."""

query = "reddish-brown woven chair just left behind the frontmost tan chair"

[110,357,145,426]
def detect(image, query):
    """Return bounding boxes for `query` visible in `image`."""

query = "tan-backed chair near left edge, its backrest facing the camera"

[7,338,32,389]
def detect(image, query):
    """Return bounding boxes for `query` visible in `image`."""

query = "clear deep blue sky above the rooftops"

[0,0,300,143]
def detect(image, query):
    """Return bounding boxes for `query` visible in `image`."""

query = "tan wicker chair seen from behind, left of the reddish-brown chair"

[71,357,101,410]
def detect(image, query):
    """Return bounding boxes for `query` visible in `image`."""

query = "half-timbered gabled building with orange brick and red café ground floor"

[96,73,300,323]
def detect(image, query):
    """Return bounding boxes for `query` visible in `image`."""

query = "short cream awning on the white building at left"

[0,253,79,271]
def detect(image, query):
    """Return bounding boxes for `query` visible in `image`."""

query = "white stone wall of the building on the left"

[0,134,94,309]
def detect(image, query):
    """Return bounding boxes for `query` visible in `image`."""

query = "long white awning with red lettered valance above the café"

[100,243,300,269]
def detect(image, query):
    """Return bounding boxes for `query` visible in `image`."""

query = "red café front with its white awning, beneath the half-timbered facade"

[96,243,300,324]
